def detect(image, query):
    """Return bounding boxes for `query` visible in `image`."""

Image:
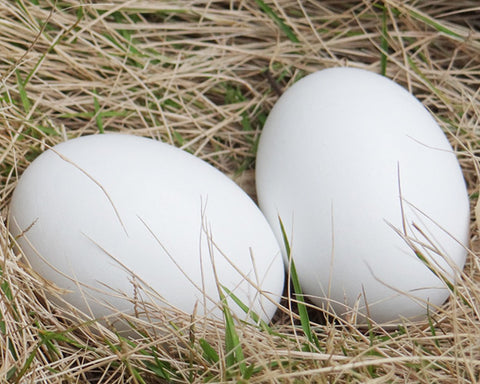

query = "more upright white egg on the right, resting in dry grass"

[256,68,469,324]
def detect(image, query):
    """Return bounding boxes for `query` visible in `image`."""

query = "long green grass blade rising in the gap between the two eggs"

[278,217,320,352]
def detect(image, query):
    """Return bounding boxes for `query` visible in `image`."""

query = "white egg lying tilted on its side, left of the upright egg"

[9,133,284,328]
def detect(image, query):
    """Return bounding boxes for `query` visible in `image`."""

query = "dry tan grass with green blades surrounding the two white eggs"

[0,0,480,383]
